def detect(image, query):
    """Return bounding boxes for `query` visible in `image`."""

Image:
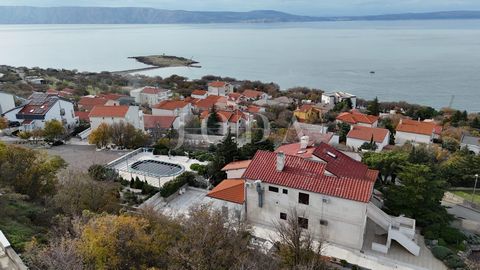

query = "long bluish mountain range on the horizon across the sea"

[0,6,480,24]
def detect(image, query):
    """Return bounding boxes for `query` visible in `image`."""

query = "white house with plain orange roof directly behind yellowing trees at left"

[89,106,145,130]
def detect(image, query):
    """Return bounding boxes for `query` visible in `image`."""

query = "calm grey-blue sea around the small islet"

[0,20,480,111]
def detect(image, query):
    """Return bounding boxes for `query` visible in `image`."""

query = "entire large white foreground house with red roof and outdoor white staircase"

[214,143,420,256]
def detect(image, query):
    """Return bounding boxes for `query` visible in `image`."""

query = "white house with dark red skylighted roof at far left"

[3,92,78,131]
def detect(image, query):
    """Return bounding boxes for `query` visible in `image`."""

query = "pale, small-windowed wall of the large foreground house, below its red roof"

[246,180,367,249]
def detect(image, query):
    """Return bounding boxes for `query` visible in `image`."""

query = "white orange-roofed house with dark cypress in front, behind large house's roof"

[346,126,390,152]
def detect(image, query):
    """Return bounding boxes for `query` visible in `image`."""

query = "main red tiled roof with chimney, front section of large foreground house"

[243,151,374,203]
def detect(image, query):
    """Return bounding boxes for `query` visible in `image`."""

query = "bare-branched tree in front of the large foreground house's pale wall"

[272,208,327,270]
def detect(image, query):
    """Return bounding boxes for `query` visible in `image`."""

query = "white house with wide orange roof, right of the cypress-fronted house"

[395,119,442,145]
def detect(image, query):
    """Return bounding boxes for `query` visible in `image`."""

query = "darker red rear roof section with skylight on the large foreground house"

[313,143,374,178]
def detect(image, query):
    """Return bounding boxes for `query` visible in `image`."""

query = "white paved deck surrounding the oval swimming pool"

[110,152,207,187]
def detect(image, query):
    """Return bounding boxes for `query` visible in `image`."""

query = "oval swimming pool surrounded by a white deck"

[131,159,185,177]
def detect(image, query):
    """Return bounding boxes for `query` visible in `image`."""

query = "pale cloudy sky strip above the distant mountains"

[0,0,480,16]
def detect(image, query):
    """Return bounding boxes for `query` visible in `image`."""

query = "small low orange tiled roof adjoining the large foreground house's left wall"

[207,179,245,204]
